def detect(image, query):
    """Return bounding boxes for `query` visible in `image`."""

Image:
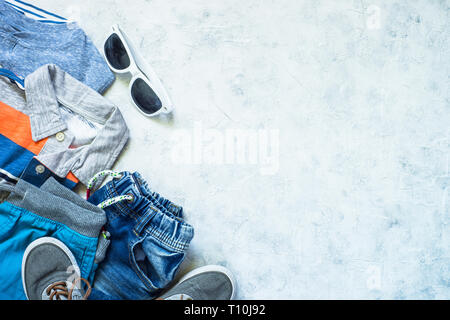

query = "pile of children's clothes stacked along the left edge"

[0,0,194,299]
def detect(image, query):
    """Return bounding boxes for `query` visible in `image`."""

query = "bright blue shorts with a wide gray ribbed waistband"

[0,178,106,300]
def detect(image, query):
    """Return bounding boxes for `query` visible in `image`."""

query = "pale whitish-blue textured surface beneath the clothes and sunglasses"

[30,0,450,299]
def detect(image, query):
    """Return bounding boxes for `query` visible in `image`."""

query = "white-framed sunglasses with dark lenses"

[103,24,173,117]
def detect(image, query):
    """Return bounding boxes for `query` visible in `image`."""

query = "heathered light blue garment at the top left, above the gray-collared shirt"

[0,0,114,93]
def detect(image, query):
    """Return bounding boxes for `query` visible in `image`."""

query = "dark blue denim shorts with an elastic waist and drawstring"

[89,172,194,300]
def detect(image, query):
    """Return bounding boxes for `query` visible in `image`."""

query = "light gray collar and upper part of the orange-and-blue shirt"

[25,65,129,184]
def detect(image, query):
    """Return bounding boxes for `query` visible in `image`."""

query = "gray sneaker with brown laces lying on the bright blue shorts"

[22,237,91,300]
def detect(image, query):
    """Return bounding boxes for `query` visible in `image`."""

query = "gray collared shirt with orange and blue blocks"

[0,64,129,185]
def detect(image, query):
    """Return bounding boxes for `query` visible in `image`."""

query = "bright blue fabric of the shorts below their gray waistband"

[0,202,98,300]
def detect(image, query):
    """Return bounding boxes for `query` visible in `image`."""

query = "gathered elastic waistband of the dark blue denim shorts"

[105,172,194,252]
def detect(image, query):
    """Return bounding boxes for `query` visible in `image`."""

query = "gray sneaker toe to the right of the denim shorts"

[158,265,236,300]
